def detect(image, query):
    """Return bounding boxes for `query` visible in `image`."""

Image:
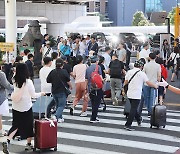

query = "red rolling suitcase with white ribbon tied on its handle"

[34,96,57,151]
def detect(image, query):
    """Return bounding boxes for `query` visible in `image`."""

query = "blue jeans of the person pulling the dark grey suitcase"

[143,86,157,114]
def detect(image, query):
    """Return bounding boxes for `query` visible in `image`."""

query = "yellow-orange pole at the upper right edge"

[174,5,180,38]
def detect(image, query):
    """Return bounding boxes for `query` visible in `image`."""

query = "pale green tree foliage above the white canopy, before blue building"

[132,11,154,26]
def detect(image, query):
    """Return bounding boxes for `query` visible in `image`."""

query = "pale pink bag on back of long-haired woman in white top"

[11,84,24,103]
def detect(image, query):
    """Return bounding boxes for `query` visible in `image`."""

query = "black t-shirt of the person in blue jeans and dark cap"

[47,68,70,94]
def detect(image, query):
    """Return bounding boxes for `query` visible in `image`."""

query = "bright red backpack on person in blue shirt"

[91,65,103,89]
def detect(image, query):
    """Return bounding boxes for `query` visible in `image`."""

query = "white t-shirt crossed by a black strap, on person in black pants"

[125,68,148,99]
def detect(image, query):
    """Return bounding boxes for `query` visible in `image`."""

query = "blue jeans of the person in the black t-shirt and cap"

[53,92,67,119]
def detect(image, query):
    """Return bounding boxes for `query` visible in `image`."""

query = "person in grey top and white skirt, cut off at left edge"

[0,67,13,137]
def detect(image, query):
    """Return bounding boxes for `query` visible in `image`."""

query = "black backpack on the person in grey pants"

[110,60,122,77]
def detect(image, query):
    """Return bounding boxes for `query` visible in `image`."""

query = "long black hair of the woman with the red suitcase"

[14,63,29,88]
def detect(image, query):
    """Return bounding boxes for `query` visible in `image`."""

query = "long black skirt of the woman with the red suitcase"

[8,108,34,139]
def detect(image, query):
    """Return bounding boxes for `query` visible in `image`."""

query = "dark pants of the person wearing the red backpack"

[89,89,103,121]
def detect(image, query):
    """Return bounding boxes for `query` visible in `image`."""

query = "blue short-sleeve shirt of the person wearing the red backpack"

[85,64,102,90]
